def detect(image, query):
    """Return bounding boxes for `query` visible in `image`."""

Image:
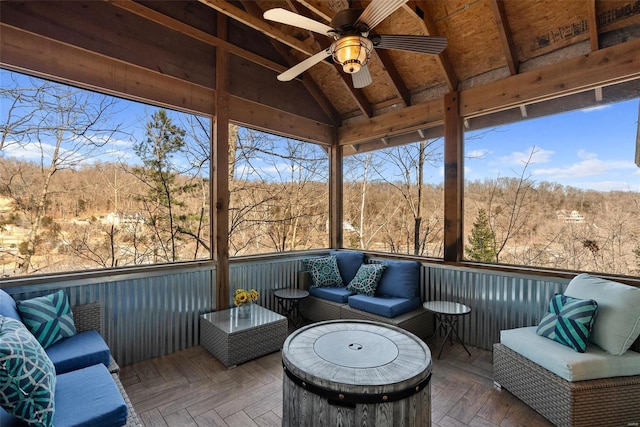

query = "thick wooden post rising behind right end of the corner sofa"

[444,92,464,262]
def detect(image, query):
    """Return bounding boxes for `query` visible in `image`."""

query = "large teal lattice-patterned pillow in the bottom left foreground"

[0,316,56,426]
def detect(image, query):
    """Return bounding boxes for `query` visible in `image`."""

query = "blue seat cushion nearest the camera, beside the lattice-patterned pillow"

[53,364,128,427]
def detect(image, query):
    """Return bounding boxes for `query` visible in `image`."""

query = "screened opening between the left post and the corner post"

[229,126,329,256]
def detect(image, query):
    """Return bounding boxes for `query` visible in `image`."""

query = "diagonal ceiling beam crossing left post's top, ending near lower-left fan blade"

[105,0,287,73]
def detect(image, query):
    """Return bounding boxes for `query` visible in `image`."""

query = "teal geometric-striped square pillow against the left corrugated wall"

[16,290,76,349]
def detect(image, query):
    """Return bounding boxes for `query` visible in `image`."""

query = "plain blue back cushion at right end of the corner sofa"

[376,261,420,298]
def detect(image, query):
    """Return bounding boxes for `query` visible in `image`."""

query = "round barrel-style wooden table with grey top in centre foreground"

[282,320,431,427]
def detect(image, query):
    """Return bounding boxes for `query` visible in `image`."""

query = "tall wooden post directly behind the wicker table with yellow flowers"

[212,14,229,310]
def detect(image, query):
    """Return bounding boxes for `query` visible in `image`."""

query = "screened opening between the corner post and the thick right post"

[343,139,444,258]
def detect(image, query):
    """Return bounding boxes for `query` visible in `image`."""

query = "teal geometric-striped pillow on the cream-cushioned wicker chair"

[537,294,598,353]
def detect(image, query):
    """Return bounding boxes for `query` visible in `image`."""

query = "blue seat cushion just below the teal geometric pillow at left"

[46,331,111,374]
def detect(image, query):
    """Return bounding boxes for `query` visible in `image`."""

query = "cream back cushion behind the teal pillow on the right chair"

[564,273,640,355]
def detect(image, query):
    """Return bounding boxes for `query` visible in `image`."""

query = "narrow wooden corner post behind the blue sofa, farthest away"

[329,132,344,249]
